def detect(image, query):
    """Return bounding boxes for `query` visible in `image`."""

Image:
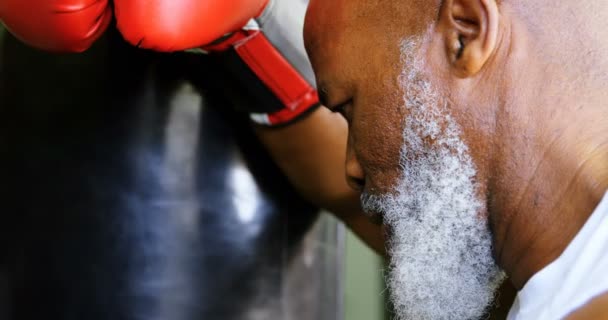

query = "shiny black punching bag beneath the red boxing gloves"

[0,25,341,320]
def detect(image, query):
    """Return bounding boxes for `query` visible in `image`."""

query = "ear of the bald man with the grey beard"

[439,0,499,78]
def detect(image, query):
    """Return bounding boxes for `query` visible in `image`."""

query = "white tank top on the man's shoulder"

[507,192,608,320]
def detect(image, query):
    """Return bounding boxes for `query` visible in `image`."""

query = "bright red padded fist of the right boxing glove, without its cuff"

[114,0,268,51]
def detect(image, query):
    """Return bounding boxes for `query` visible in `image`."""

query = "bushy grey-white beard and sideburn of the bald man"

[362,35,504,320]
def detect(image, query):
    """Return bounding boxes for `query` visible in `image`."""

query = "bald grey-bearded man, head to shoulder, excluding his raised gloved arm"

[305,0,608,319]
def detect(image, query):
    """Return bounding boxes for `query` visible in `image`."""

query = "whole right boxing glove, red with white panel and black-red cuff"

[114,0,319,126]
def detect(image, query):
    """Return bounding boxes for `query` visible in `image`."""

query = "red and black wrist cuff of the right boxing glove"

[202,16,319,126]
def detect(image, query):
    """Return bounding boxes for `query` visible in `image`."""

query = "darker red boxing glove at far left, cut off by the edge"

[0,0,112,52]
